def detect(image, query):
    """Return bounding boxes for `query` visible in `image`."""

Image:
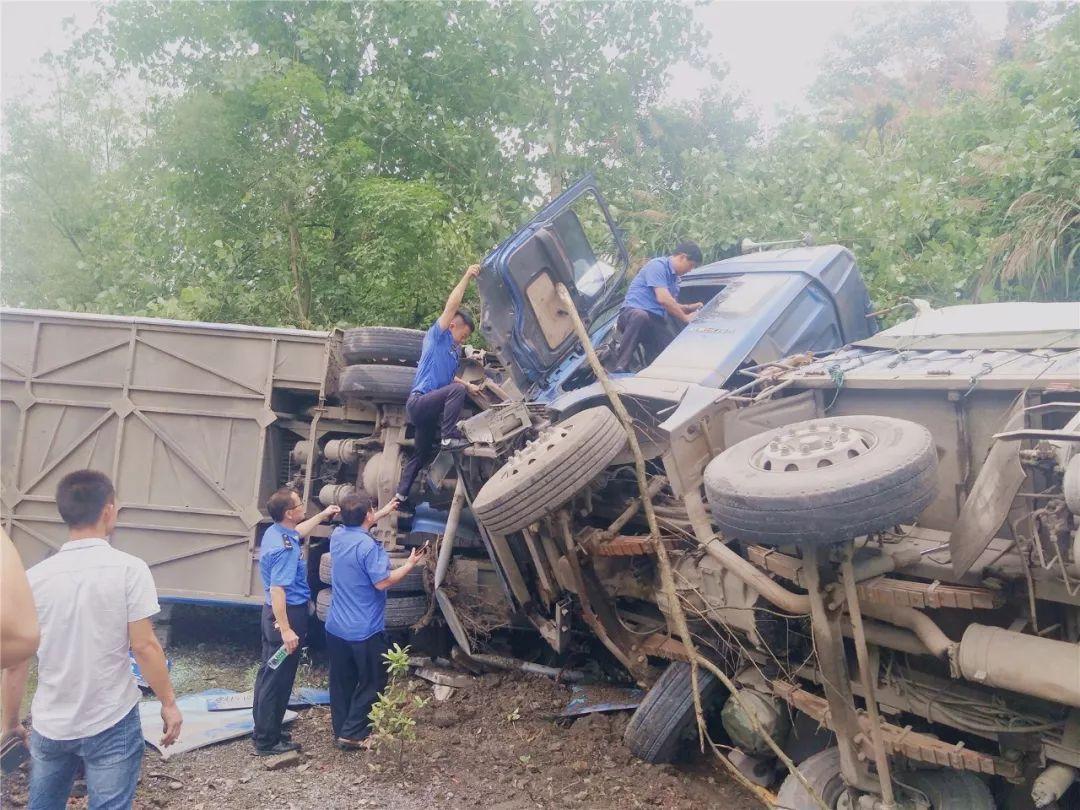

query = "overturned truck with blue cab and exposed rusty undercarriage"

[459,177,1080,808]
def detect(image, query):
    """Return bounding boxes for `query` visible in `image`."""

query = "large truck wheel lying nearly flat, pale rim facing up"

[705,416,937,545]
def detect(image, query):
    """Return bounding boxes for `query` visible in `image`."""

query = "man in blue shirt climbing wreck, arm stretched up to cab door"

[397,265,480,503]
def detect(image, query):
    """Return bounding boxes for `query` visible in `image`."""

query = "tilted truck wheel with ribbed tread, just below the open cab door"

[473,407,626,535]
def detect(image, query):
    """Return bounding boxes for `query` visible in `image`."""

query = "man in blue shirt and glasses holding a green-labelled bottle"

[252,487,340,756]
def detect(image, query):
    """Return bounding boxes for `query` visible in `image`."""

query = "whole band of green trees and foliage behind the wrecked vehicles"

[0,0,1080,326]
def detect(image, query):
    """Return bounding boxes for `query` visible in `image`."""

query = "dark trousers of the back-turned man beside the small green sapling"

[326,633,390,740]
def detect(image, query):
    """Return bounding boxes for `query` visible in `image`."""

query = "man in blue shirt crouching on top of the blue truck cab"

[613,242,702,372]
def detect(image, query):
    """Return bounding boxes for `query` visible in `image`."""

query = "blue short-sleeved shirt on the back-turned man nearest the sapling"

[326,526,390,642]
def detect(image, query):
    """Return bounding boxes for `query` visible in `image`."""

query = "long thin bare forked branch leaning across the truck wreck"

[555,283,831,810]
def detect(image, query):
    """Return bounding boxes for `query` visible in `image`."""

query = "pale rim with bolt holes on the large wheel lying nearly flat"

[750,422,877,472]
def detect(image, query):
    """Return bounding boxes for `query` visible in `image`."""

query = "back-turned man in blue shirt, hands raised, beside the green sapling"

[326,492,424,751]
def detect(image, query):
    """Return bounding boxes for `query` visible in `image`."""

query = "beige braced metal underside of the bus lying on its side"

[0,310,328,602]
